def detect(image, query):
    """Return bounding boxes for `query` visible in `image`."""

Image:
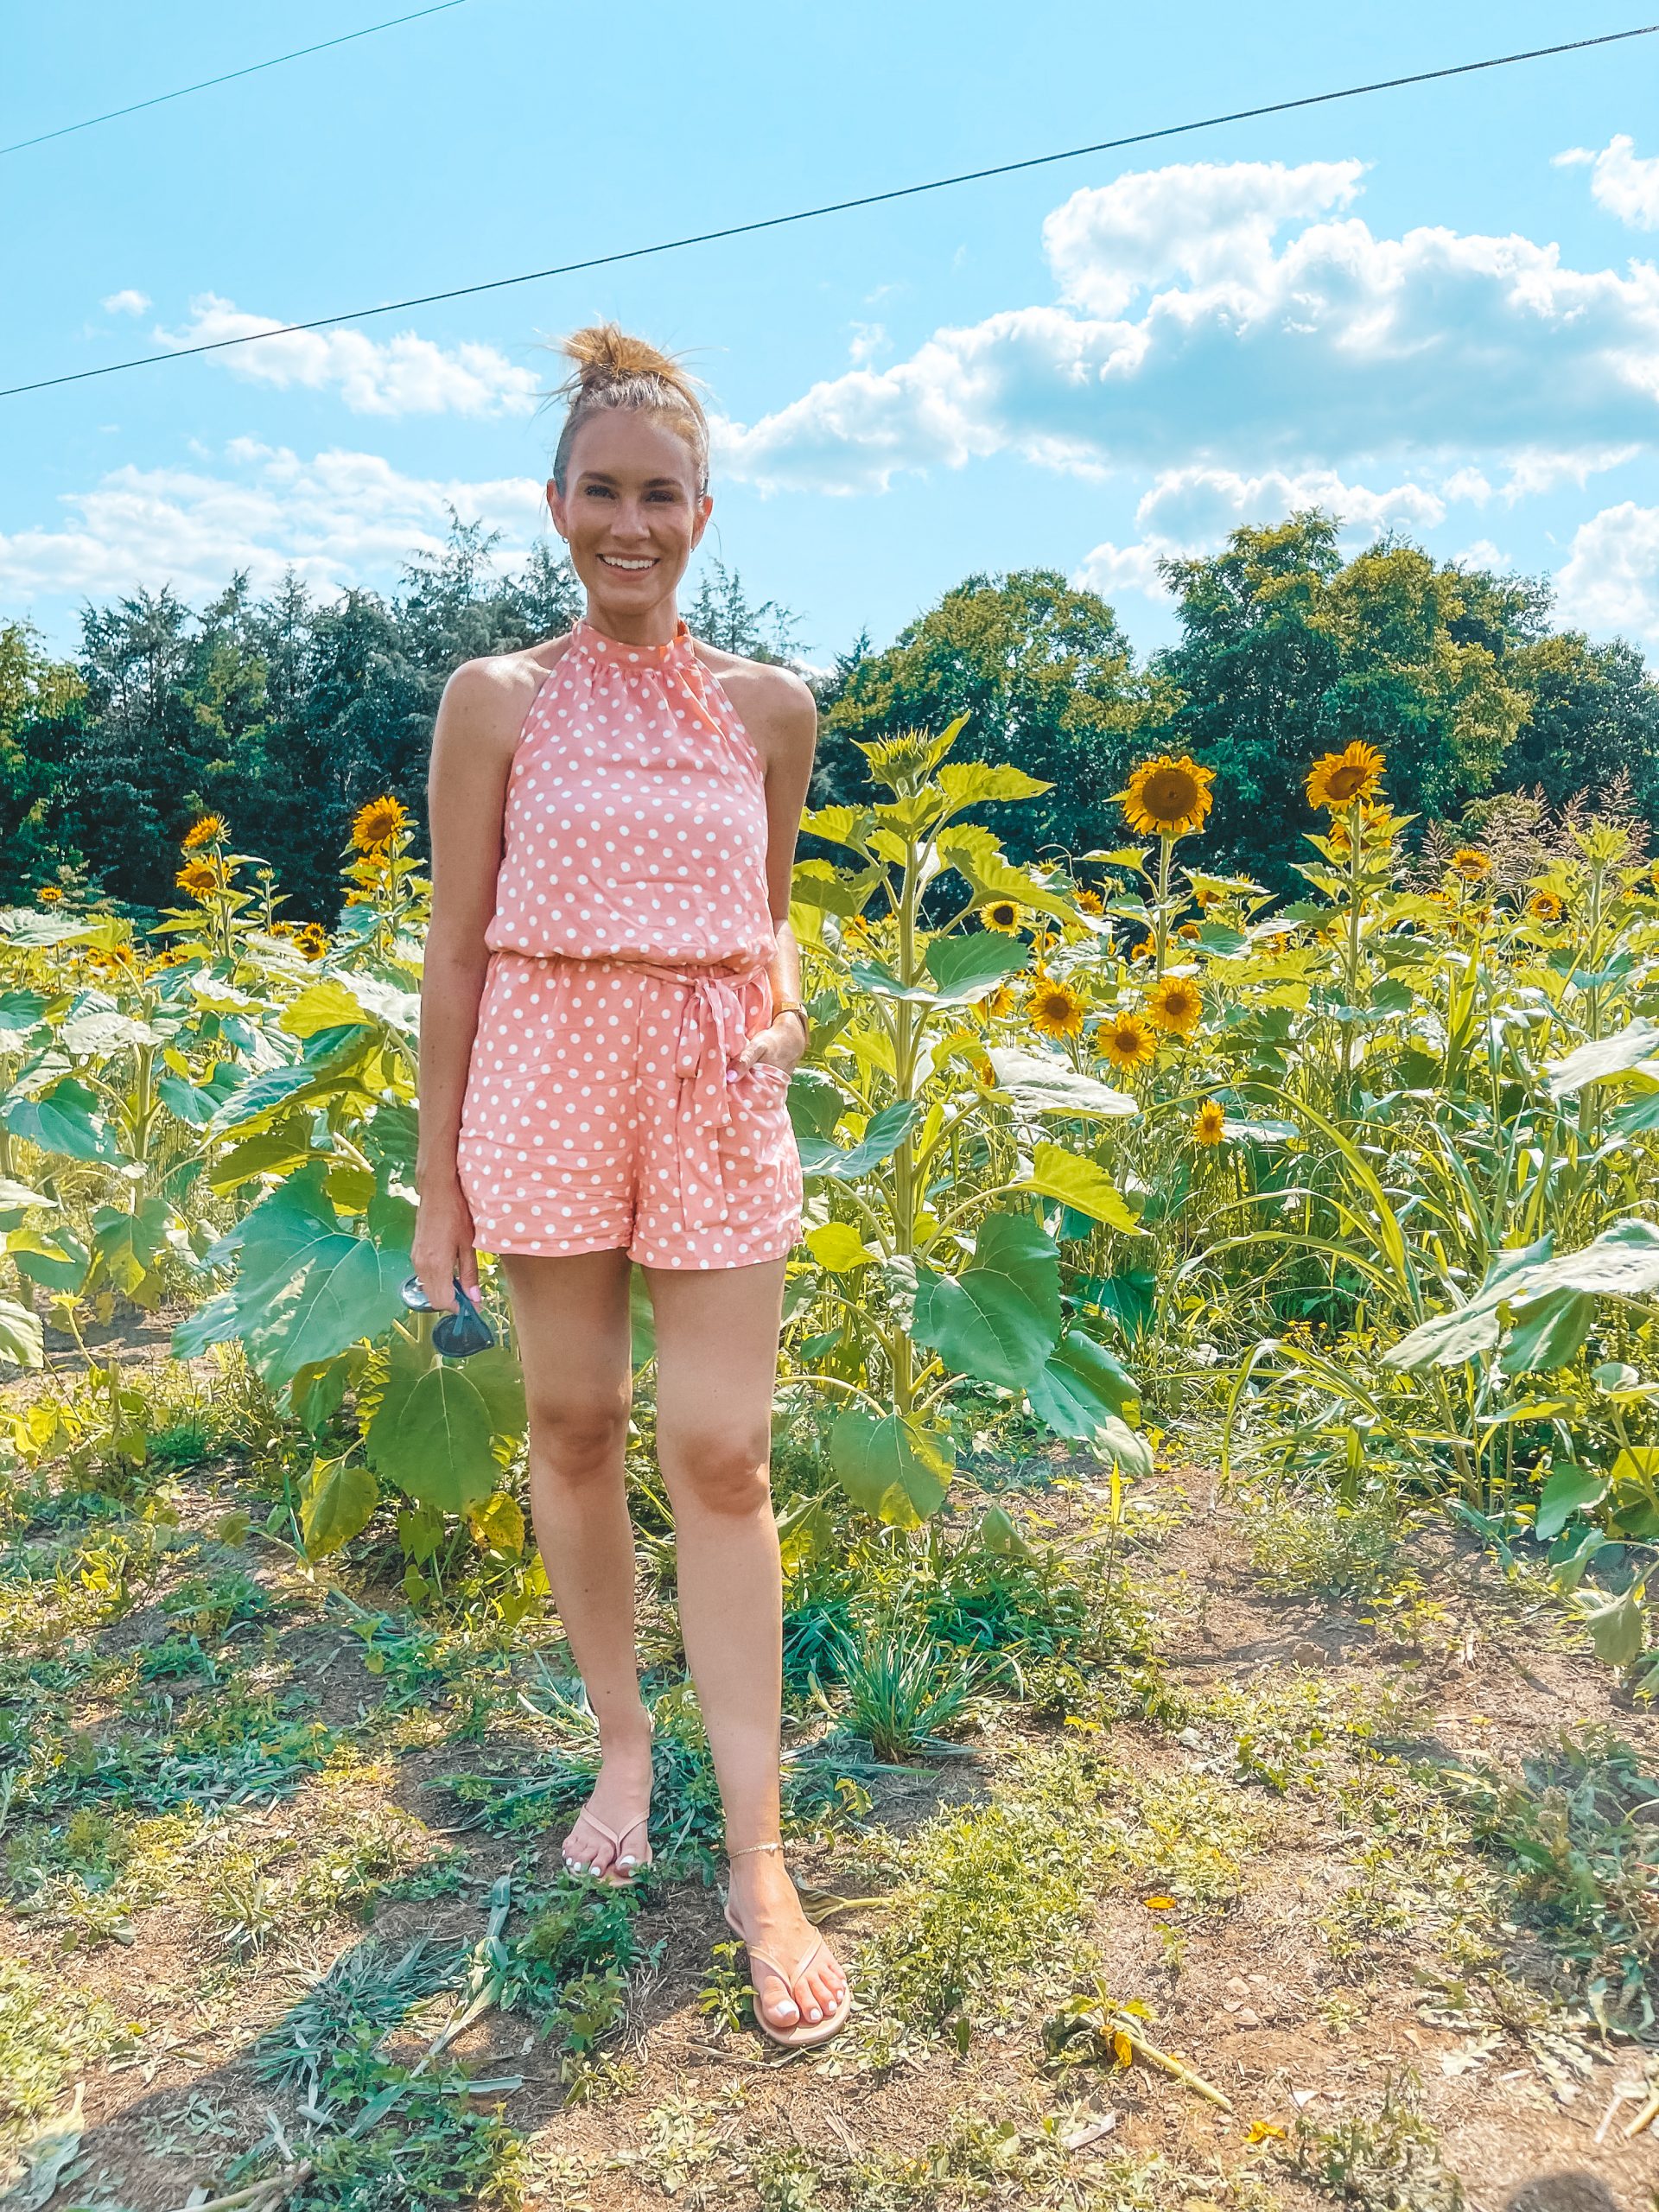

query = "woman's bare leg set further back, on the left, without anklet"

[502,1249,651,1880]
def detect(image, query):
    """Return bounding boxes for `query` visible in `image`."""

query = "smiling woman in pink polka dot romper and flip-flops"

[414,325,852,2044]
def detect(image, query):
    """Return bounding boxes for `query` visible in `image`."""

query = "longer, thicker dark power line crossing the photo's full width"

[0,19,1659,400]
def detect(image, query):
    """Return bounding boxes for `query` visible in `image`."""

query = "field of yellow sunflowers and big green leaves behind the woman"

[0,726,1659,1670]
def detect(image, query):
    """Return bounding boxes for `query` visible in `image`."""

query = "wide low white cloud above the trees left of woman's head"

[0,438,544,600]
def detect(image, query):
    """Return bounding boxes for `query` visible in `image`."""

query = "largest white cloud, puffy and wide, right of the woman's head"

[719,163,1659,493]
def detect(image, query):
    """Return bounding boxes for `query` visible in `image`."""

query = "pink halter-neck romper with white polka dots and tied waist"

[460,621,803,1268]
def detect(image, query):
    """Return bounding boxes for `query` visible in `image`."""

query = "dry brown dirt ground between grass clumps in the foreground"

[0,1433,1659,2212]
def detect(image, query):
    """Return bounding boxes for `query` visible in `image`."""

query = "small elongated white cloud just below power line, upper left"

[155,292,540,416]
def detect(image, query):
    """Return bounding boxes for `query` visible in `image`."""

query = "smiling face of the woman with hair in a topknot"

[546,407,715,644]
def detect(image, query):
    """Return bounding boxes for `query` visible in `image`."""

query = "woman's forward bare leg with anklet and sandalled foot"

[646,1259,847,2029]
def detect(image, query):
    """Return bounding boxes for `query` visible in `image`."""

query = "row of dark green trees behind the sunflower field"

[0,511,1659,923]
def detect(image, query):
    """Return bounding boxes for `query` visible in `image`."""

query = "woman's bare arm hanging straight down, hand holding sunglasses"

[414,661,524,1307]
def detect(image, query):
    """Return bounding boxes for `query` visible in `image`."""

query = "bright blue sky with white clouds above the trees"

[0,0,1659,661]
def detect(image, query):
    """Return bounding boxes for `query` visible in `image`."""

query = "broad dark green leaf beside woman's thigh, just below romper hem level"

[913,1214,1059,1389]
